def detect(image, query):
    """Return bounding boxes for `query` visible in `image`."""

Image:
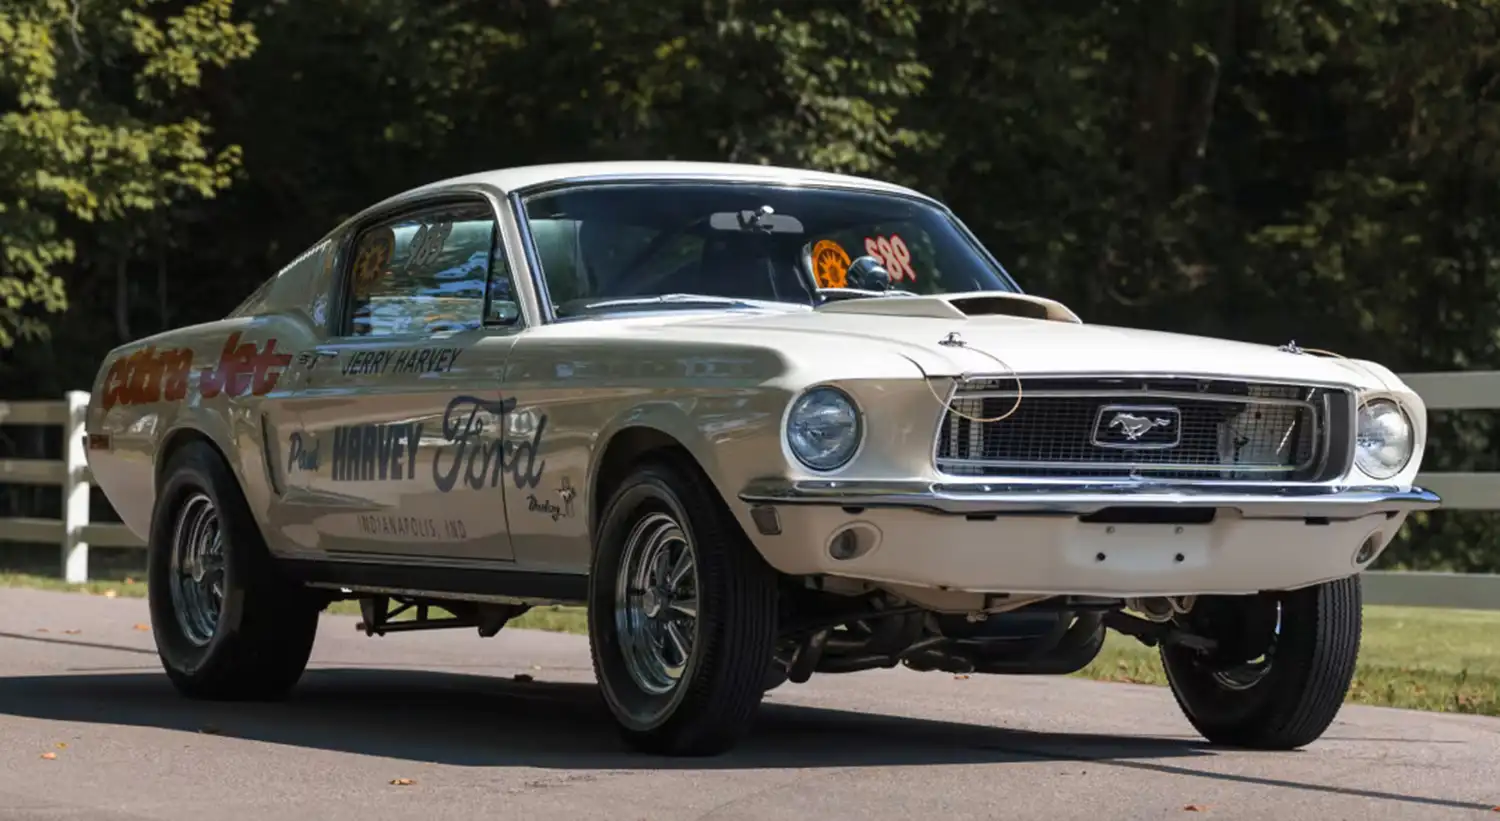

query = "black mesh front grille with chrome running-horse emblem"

[936,377,1355,482]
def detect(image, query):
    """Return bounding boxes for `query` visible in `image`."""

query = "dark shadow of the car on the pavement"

[0,668,1206,770]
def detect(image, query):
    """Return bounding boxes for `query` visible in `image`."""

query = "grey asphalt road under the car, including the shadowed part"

[0,590,1500,821]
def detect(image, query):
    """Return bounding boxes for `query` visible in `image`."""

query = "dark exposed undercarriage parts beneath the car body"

[327,579,1277,689]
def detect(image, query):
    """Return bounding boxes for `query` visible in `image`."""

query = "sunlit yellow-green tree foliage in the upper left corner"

[0,0,257,347]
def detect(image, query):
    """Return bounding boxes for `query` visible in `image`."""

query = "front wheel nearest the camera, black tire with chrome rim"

[588,459,777,756]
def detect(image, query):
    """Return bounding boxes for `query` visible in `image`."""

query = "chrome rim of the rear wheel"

[168,494,224,647]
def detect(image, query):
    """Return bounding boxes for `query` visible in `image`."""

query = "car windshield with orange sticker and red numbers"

[525,183,1016,317]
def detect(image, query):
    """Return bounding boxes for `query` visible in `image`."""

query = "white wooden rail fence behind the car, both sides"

[0,381,1500,609]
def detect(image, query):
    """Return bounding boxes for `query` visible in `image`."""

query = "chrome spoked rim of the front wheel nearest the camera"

[615,513,698,695]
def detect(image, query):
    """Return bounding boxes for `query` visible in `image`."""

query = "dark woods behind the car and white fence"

[0,0,1500,570]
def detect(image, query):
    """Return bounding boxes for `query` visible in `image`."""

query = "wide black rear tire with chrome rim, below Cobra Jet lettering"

[147,441,323,701]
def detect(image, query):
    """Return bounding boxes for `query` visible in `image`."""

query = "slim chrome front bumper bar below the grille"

[740,479,1442,519]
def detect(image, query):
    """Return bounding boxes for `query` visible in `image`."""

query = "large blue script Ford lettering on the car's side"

[432,396,548,492]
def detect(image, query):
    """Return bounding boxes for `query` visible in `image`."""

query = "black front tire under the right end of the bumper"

[1161,576,1364,750]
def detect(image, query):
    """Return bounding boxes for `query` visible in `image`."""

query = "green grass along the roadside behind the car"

[0,573,1500,716]
